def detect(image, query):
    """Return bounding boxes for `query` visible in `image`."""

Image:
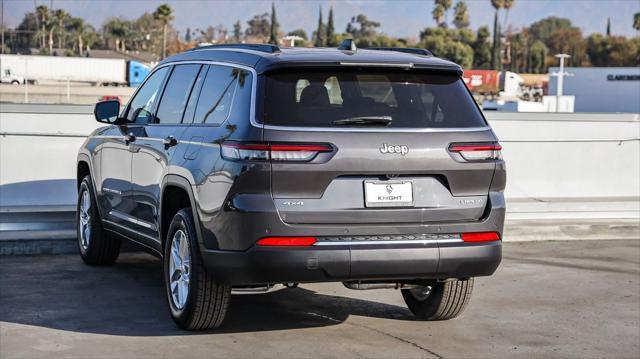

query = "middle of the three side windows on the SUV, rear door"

[156,65,201,123]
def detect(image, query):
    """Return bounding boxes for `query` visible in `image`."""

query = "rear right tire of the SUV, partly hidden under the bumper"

[402,278,473,320]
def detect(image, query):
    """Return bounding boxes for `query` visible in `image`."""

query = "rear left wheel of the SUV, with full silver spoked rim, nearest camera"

[164,208,231,330]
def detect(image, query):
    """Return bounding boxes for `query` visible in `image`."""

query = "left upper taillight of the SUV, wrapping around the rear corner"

[220,141,333,162]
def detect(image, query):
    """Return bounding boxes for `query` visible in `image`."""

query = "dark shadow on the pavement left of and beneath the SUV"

[0,253,412,336]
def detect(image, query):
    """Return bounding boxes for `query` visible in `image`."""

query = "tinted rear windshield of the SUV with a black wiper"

[263,69,486,128]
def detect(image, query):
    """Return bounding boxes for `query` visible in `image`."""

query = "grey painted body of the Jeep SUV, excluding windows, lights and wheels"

[78,46,506,284]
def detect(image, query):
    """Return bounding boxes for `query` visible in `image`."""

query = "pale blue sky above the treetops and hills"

[4,0,640,38]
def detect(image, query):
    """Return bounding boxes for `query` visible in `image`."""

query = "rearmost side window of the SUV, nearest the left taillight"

[193,65,242,125]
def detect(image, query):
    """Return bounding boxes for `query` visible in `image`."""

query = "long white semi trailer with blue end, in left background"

[0,55,149,86]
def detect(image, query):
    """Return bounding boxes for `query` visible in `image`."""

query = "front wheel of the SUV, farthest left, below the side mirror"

[76,176,120,265]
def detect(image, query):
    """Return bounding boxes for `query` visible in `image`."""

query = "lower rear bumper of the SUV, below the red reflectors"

[202,241,502,285]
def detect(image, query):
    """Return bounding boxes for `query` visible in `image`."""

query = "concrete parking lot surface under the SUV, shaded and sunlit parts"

[0,240,640,359]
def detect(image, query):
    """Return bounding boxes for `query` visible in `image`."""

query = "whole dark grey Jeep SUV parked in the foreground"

[77,42,505,330]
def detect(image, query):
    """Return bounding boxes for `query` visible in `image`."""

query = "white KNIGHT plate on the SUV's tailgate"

[364,181,413,207]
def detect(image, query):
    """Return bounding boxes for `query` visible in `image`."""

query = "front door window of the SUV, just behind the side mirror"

[125,67,169,124]
